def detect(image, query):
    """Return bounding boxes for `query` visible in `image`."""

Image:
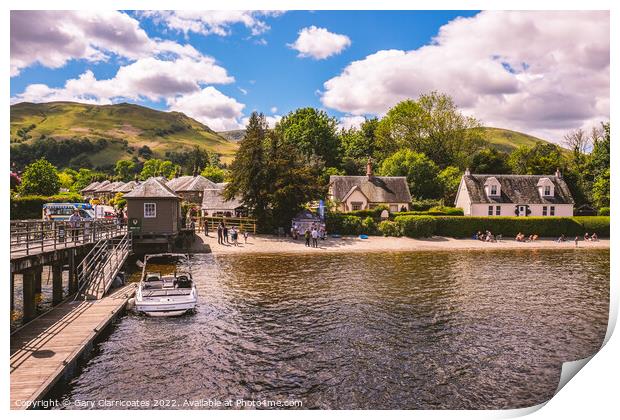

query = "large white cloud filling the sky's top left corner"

[11,10,200,76]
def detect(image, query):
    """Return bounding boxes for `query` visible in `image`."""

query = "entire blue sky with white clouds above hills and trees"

[10,11,610,143]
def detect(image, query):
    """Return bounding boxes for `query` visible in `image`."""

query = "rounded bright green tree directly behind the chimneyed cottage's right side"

[380,149,443,199]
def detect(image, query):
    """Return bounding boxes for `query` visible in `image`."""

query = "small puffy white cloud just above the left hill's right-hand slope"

[167,86,245,131]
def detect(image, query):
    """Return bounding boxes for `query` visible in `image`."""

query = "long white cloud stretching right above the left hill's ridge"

[11,56,234,103]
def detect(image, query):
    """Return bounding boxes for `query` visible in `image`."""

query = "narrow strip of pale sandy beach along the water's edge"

[196,233,609,254]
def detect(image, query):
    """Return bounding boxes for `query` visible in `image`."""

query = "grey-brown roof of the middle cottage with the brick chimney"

[329,175,411,203]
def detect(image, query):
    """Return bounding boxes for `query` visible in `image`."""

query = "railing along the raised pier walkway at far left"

[10,219,127,258]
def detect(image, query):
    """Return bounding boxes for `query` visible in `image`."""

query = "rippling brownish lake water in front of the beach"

[54,250,609,409]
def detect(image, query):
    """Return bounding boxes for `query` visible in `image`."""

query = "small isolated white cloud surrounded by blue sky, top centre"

[289,25,351,60]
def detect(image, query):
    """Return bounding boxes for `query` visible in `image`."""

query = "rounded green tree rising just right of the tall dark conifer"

[275,108,340,166]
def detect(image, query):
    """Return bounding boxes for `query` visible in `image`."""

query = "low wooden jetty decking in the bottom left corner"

[11,284,136,409]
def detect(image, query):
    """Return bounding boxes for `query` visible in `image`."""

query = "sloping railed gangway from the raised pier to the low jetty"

[75,232,131,300]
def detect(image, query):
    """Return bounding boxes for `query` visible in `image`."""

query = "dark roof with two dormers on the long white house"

[463,174,574,204]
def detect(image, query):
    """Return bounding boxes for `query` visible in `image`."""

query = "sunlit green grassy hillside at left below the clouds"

[11,102,237,166]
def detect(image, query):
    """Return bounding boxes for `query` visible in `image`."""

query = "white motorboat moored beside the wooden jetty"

[135,253,198,316]
